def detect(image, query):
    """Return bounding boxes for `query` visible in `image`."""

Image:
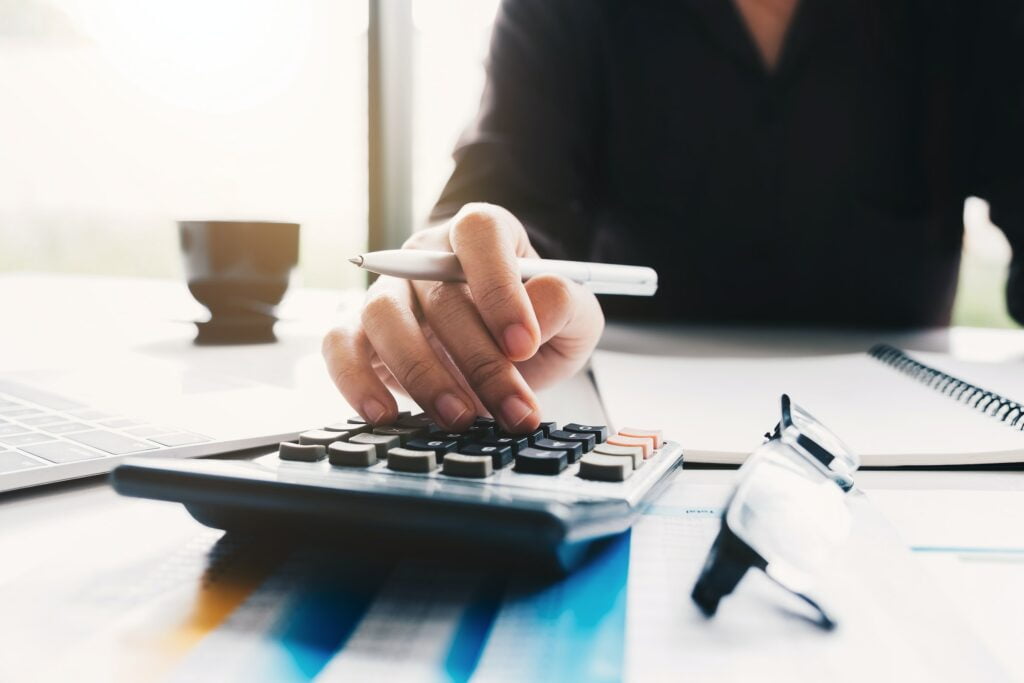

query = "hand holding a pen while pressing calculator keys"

[324,204,604,432]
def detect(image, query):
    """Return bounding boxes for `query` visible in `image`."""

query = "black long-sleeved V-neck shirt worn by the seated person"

[434,0,1024,327]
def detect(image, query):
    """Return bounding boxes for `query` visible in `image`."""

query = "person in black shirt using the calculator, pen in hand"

[324,0,1024,431]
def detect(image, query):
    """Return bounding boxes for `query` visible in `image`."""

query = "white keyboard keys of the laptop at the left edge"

[0,380,212,474]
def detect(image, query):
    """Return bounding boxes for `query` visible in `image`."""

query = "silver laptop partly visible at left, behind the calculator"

[0,353,351,492]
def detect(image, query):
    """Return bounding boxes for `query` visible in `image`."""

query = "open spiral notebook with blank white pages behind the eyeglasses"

[593,346,1024,467]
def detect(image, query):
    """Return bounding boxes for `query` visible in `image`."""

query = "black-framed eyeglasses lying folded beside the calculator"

[691,394,860,630]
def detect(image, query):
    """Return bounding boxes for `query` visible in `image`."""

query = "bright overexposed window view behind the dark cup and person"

[0,0,1014,327]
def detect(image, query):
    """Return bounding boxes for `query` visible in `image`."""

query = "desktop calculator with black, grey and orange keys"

[111,413,683,572]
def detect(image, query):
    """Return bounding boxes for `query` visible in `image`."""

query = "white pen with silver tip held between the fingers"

[348,249,657,296]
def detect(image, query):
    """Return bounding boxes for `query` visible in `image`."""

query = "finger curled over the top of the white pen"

[449,204,541,360]
